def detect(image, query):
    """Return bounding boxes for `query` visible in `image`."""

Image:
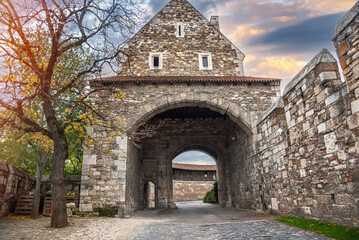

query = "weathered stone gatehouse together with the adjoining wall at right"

[80,0,359,226]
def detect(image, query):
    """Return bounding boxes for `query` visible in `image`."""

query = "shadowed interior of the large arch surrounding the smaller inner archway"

[126,104,254,213]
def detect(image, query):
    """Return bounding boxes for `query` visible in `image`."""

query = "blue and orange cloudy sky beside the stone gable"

[146,0,356,90]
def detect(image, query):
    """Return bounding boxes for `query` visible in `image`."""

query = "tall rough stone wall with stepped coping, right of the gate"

[252,3,359,227]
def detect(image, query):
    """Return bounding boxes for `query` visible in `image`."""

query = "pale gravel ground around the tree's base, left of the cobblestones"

[0,217,144,240]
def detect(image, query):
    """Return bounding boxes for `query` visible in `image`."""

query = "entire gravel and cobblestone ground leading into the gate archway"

[0,202,328,240]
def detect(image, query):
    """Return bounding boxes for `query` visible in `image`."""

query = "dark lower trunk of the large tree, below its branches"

[51,131,68,228]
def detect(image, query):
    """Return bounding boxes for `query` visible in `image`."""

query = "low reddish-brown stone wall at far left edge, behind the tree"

[0,161,35,217]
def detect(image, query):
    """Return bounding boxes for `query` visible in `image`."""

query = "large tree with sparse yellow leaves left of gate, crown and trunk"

[0,0,142,227]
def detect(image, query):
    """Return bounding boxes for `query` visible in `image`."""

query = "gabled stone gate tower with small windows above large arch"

[81,0,280,212]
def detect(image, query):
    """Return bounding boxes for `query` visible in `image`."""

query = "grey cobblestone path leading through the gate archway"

[130,202,329,240]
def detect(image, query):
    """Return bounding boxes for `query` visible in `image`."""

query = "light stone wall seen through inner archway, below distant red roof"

[173,180,213,201]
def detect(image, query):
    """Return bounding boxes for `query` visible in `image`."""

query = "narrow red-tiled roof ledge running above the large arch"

[90,76,281,82]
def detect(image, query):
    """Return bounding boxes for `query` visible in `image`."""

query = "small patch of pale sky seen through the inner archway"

[173,151,216,165]
